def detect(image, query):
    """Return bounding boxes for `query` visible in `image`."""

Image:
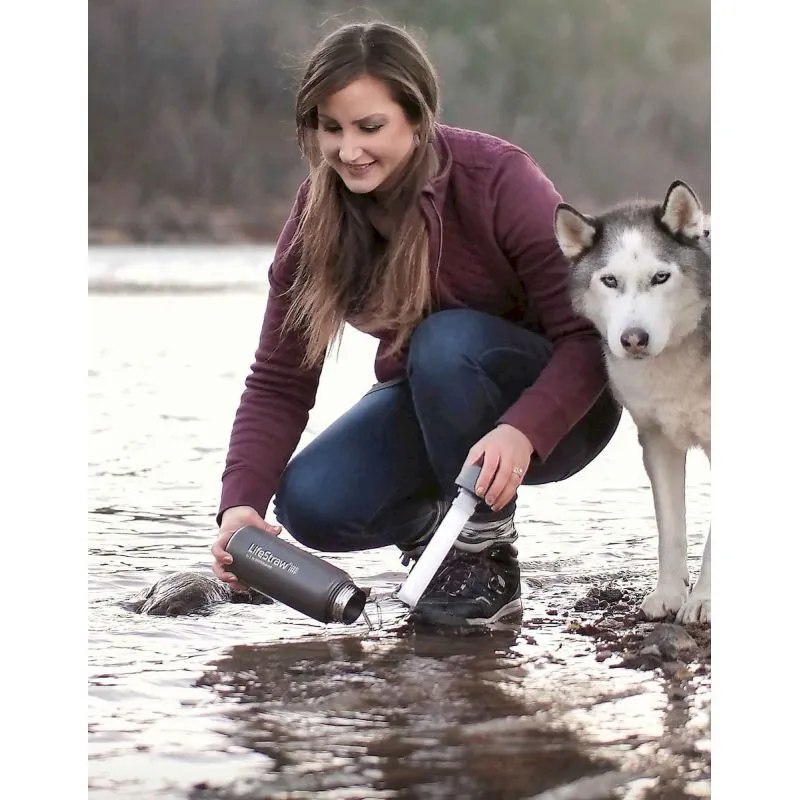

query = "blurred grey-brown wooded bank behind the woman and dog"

[89,0,711,243]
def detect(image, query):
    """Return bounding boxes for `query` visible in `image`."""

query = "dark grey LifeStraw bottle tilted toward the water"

[226,525,367,625]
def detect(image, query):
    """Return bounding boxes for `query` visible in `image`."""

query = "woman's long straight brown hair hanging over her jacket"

[284,22,439,365]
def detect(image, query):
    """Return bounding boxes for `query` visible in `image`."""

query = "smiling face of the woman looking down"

[317,76,416,194]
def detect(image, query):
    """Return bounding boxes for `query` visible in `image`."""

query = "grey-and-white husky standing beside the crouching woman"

[555,181,711,623]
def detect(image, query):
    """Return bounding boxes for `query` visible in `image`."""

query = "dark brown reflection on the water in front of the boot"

[192,630,615,798]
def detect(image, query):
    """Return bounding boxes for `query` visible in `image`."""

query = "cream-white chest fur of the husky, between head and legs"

[606,332,711,449]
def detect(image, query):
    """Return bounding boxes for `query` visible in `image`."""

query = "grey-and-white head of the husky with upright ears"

[554,181,711,358]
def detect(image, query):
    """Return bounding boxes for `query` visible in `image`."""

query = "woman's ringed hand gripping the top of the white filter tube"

[464,424,533,511]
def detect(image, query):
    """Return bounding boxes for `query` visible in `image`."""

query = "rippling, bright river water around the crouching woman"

[88,248,710,800]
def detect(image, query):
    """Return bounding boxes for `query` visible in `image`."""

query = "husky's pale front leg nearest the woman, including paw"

[639,428,689,619]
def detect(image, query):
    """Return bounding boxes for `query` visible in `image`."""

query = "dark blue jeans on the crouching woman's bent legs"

[275,309,621,552]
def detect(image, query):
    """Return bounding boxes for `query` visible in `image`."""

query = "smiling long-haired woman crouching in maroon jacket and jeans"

[212,23,620,624]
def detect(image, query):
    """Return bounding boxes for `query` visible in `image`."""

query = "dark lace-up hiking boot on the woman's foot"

[410,542,522,625]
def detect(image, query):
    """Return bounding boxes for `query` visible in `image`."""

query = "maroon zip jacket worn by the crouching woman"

[218,119,606,519]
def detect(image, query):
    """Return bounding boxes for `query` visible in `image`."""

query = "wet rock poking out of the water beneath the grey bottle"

[122,572,273,617]
